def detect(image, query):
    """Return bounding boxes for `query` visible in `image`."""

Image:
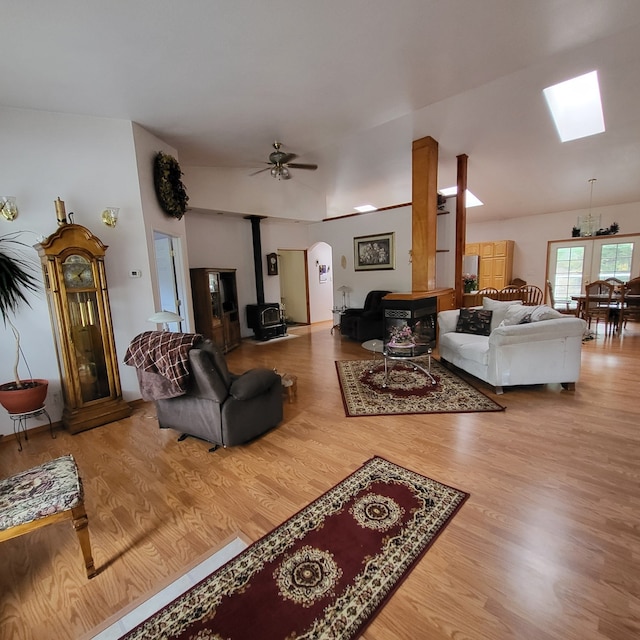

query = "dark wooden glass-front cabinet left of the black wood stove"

[190,268,241,352]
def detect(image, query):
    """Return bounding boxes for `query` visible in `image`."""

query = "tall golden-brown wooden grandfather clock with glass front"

[36,216,131,433]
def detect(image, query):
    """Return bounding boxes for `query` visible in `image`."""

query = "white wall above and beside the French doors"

[467,202,640,290]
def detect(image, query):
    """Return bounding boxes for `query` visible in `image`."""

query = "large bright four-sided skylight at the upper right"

[543,71,605,142]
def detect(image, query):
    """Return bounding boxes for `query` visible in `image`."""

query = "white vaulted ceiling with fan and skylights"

[5,0,640,221]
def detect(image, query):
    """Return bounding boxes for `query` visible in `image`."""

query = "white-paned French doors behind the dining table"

[547,235,640,303]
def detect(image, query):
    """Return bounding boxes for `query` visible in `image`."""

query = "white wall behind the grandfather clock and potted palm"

[0,108,153,434]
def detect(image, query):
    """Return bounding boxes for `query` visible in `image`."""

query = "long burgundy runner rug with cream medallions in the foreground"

[123,457,468,640]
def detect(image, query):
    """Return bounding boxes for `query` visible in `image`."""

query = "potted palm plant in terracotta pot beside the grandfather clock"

[0,233,49,413]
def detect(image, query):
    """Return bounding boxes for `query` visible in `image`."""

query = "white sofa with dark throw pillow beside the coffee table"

[438,299,586,394]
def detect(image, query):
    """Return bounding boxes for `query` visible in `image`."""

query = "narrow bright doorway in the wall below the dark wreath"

[153,231,184,332]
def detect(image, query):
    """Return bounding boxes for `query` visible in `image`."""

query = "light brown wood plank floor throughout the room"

[0,323,640,640]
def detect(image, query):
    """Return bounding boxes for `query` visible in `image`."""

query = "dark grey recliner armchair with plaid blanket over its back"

[125,332,283,451]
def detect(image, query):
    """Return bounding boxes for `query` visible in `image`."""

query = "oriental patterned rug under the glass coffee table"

[336,356,504,417]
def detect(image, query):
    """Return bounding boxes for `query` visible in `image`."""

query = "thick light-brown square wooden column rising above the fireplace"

[411,136,438,292]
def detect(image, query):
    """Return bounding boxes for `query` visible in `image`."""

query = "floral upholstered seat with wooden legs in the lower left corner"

[0,455,96,578]
